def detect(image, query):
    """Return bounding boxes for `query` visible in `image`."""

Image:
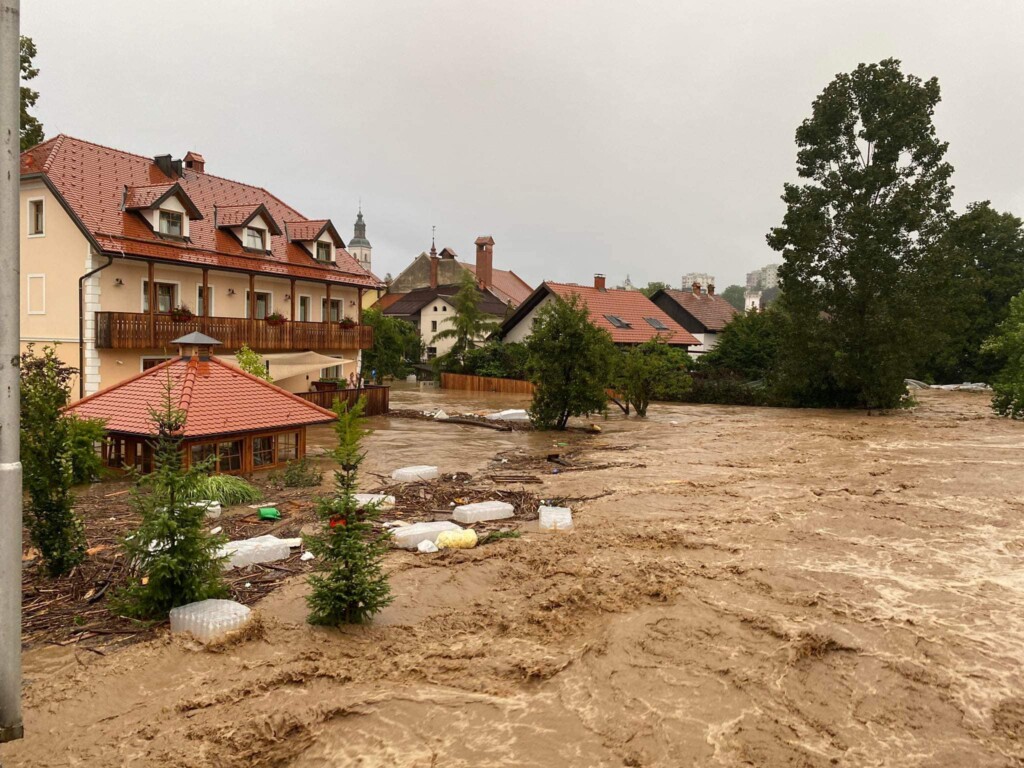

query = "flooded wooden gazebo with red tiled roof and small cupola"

[68,333,335,474]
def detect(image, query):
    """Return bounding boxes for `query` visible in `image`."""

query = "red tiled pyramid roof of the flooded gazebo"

[68,356,335,438]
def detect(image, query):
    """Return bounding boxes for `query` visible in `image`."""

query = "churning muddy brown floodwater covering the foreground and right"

[0,392,1024,767]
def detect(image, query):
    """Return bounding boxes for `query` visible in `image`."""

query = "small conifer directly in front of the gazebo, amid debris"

[119,374,227,618]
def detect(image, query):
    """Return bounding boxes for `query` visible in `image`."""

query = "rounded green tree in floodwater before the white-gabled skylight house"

[526,294,615,429]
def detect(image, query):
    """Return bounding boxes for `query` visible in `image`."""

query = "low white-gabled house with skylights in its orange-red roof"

[498,274,699,349]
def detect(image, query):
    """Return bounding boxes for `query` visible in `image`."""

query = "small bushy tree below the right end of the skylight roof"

[614,337,691,418]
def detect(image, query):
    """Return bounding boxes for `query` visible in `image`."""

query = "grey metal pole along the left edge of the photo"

[0,0,24,743]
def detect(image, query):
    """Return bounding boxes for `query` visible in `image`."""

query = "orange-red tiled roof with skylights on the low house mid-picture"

[501,283,700,346]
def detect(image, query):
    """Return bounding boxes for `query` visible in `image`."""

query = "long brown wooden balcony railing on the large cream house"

[96,312,374,352]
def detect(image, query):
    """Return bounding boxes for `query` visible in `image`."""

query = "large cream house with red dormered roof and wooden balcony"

[20,135,384,396]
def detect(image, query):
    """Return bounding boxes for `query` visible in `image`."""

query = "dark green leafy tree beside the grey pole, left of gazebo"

[20,344,85,575]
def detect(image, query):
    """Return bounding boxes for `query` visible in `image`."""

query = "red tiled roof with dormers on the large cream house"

[22,134,384,288]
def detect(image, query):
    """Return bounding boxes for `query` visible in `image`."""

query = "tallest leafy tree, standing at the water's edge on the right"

[768,58,952,408]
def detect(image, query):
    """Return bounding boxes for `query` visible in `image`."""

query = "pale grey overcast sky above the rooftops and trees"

[22,0,1024,290]
